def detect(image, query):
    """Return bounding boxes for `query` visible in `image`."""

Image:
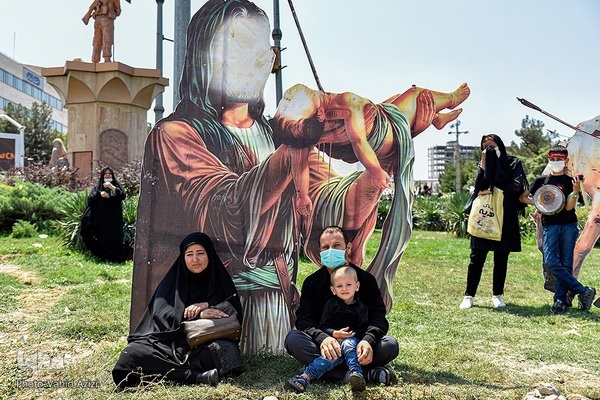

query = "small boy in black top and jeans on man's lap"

[288,266,369,392]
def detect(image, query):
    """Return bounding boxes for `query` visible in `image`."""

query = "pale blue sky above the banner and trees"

[0,0,600,180]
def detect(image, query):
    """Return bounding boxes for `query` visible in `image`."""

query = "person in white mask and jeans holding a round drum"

[522,146,596,314]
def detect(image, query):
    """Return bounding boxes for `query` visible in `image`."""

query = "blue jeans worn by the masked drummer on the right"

[542,222,585,303]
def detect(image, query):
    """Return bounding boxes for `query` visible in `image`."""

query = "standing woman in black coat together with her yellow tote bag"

[460,134,528,309]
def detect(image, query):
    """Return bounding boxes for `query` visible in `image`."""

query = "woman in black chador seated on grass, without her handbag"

[112,232,245,387]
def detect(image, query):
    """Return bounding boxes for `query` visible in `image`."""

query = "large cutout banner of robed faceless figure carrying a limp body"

[130,0,470,353]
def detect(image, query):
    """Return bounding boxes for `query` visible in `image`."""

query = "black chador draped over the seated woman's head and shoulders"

[129,232,242,342]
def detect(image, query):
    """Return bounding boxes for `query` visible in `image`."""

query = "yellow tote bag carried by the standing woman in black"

[467,187,504,241]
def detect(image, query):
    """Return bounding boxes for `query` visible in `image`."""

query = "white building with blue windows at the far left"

[0,52,68,134]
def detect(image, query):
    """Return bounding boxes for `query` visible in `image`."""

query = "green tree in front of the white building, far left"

[0,102,61,162]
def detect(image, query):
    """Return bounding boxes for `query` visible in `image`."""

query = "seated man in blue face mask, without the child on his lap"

[285,226,399,385]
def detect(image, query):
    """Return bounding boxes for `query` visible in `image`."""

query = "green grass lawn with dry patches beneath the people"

[0,231,600,399]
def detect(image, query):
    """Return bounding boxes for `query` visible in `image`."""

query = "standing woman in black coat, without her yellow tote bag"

[460,134,528,309]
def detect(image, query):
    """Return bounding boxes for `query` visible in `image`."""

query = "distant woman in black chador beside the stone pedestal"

[81,167,127,262]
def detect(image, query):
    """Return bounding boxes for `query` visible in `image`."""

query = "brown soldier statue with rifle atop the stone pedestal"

[82,0,121,63]
